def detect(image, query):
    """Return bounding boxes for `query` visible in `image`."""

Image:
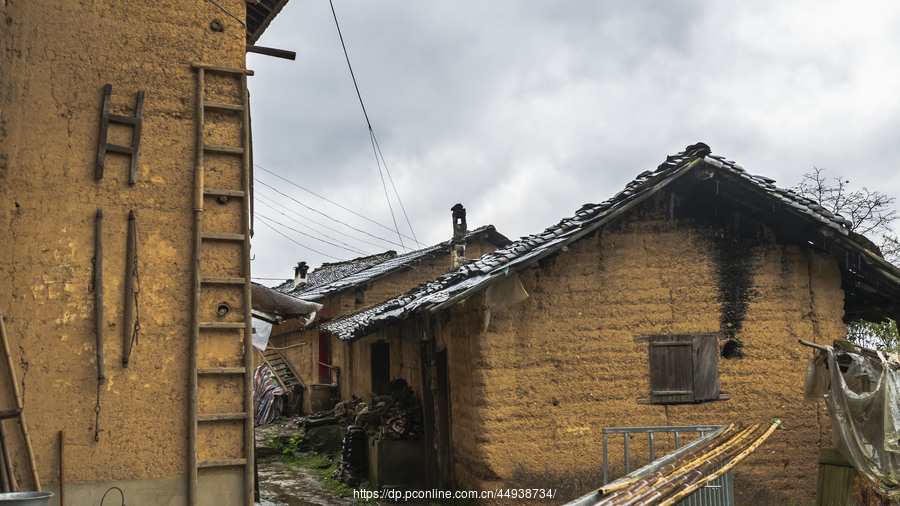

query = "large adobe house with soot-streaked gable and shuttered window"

[321,143,900,504]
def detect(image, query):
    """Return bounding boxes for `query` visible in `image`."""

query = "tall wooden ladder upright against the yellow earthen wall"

[188,63,254,506]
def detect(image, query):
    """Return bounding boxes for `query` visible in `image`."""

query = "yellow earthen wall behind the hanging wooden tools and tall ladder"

[0,0,246,498]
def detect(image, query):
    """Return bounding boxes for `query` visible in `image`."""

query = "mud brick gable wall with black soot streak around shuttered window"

[443,221,846,504]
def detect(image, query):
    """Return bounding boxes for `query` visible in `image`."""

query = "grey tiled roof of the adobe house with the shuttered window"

[320,143,900,340]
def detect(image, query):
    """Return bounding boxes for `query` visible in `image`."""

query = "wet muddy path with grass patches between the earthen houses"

[256,419,355,506]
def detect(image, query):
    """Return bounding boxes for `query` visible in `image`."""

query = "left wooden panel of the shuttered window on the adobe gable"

[650,334,694,404]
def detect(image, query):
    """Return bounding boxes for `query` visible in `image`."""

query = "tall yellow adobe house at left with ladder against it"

[0,0,286,506]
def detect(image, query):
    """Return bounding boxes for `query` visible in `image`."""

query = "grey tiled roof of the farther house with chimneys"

[275,225,509,300]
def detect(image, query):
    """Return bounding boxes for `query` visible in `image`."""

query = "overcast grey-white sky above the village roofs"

[247,0,900,285]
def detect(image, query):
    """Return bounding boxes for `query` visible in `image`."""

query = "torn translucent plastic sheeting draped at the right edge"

[804,341,900,492]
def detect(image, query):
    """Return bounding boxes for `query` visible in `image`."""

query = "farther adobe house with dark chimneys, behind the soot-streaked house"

[266,204,509,412]
